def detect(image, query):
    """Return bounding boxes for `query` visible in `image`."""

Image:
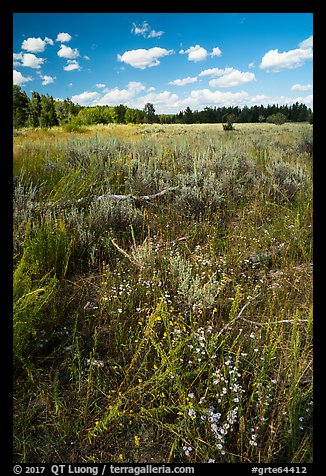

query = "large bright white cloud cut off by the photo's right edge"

[260,36,313,73]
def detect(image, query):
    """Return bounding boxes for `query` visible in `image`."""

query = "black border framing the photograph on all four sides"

[0,0,318,468]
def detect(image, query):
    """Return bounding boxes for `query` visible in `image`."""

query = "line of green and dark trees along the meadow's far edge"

[13,85,313,129]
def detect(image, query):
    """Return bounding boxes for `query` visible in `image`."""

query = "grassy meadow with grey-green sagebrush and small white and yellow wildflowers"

[13,123,313,464]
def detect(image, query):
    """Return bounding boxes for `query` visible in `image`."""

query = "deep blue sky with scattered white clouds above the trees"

[13,12,313,113]
